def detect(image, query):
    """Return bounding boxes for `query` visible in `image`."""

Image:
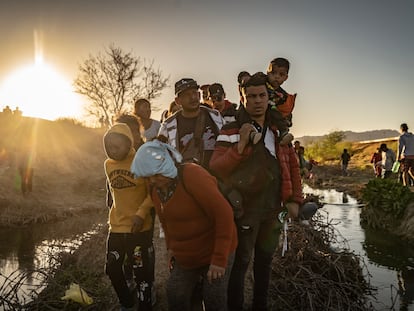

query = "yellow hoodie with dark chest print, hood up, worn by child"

[104,123,154,233]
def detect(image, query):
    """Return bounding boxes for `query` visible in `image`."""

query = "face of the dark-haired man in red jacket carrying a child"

[242,85,269,118]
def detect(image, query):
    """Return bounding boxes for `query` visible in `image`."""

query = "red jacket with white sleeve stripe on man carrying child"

[210,122,303,204]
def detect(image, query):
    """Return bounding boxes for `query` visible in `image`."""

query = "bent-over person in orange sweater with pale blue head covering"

[131,140,237,311]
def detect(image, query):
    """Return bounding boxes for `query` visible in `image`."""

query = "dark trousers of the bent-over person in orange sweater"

[167,254,234,311]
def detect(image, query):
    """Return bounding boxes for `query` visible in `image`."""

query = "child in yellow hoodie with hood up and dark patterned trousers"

[104,123,154,311]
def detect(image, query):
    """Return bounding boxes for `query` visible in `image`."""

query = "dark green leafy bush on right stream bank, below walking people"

[362,178,414,219]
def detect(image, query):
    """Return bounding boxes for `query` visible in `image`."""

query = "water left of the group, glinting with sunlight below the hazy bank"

[0,210,107,309]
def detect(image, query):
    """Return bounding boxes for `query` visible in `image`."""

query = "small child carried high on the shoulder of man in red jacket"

[266,57,296,144]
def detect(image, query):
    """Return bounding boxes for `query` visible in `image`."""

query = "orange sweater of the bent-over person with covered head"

[152,163,237,268]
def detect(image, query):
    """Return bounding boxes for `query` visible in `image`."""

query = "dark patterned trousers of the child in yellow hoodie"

[105,230,155,310]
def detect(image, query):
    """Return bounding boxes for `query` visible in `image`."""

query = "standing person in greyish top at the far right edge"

[397,123,414,186]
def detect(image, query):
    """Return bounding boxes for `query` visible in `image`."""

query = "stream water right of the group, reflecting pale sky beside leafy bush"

[304,186,414,311]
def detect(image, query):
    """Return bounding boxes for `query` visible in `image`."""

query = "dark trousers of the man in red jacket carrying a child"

[228,211,281,311]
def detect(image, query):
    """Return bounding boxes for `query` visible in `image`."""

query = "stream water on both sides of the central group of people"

[0,190,414,311]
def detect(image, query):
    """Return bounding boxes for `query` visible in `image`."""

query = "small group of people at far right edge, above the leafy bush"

[370,123,414,186]
